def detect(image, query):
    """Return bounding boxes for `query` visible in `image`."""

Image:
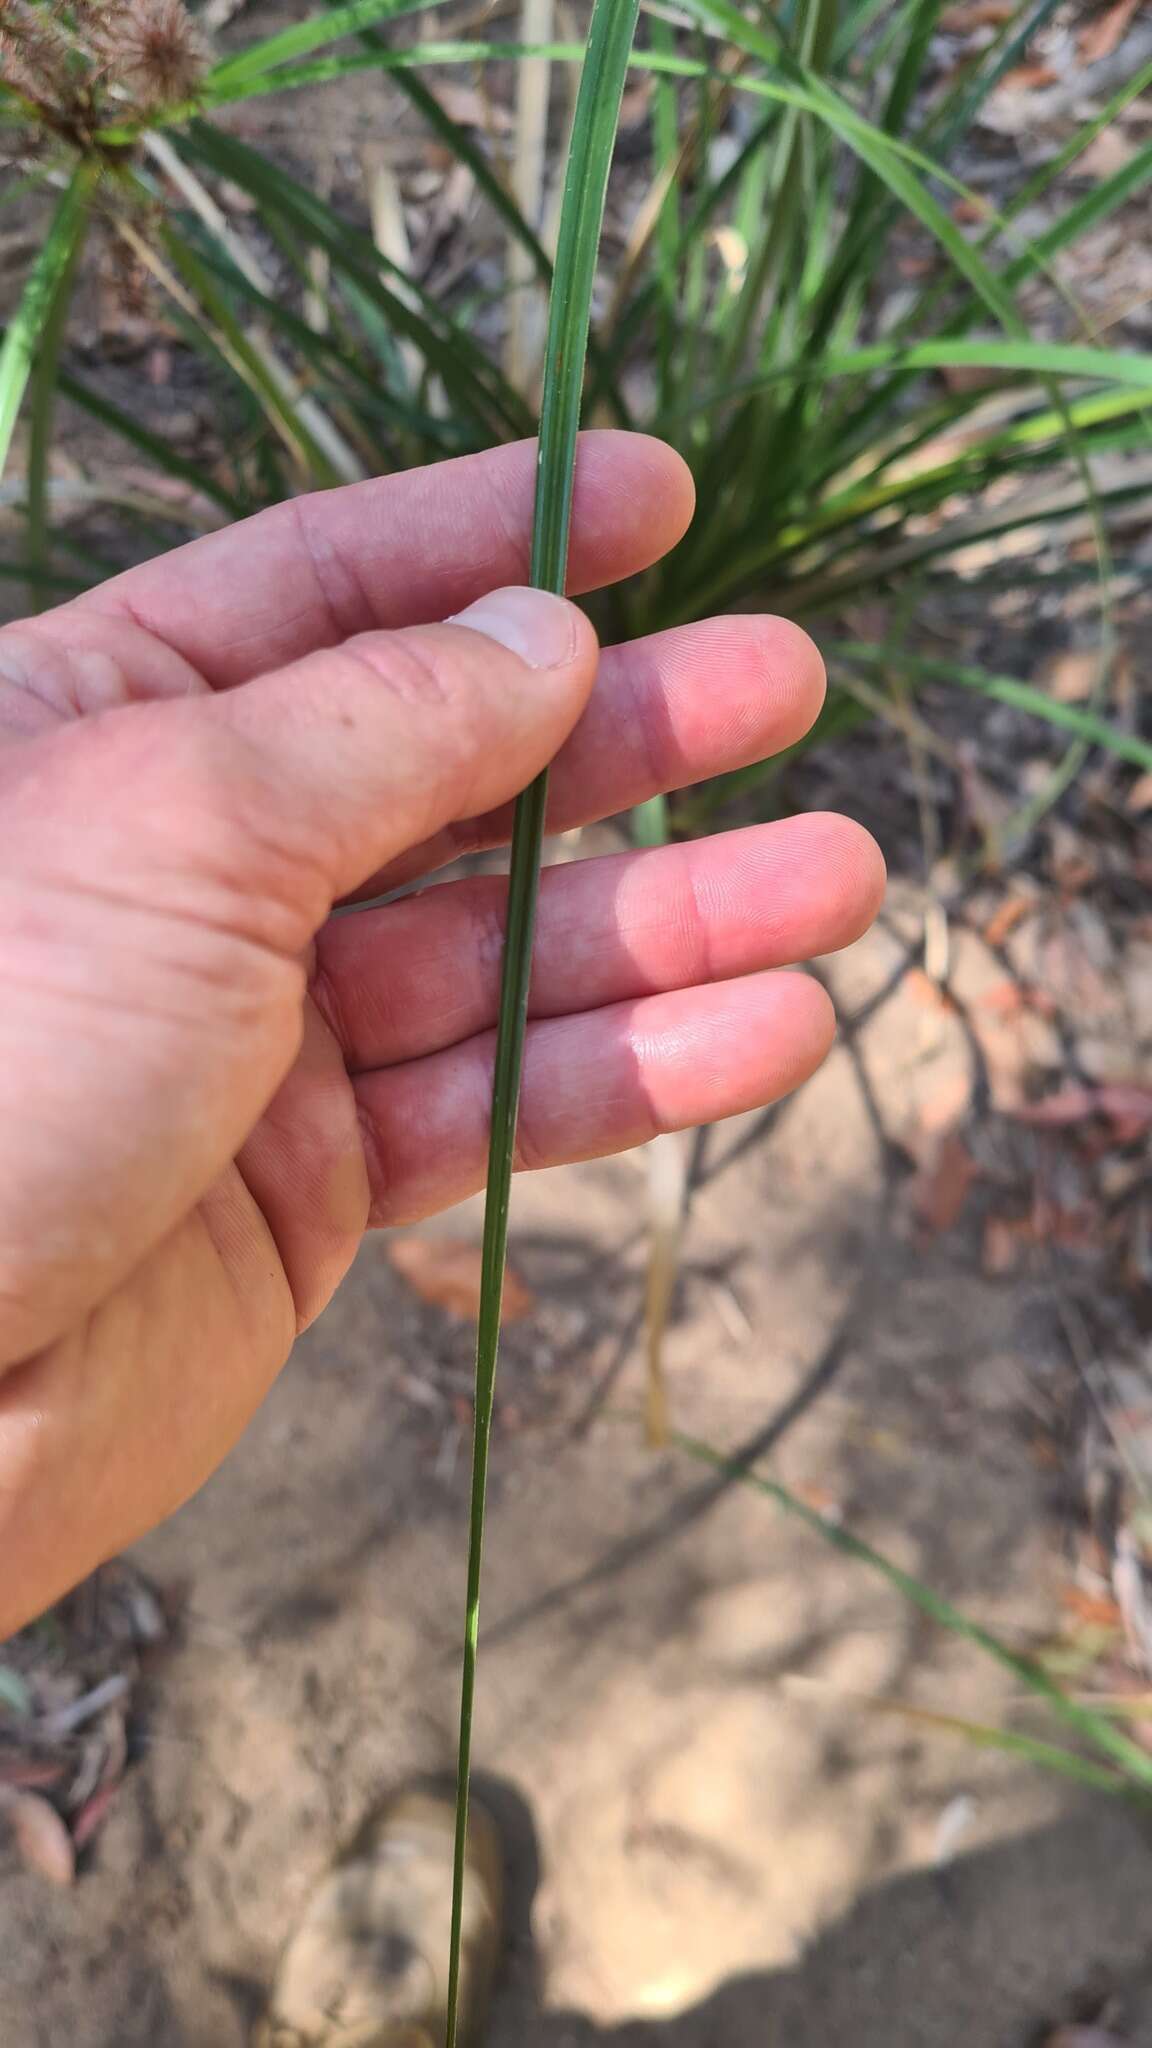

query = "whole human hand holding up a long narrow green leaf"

[0,434,883,1634]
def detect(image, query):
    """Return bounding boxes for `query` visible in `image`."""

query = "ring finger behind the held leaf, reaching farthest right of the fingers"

[314,813,883,1073]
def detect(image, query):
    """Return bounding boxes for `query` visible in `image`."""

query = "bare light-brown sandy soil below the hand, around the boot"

[0,889,1152,2048]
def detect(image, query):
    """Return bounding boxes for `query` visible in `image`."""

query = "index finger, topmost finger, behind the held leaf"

[53,430,693,688]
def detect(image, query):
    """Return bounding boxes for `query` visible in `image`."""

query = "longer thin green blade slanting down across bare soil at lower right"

[672,1434,1152,1794]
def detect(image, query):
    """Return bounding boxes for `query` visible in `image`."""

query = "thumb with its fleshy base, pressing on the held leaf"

[0,590,596,1368]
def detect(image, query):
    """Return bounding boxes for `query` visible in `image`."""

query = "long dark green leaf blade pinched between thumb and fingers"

[447,0,640,2048]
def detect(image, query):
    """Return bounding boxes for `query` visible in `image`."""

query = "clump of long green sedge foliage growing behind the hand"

[0,0,1152,782]
